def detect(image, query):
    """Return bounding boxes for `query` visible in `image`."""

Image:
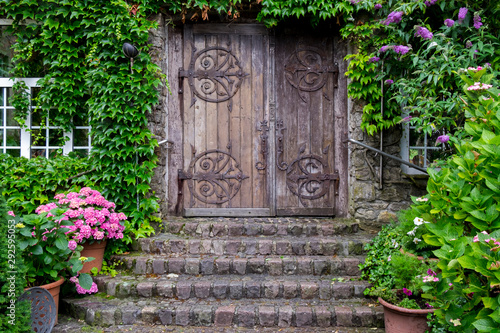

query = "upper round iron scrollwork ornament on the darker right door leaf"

[285,46,339,102]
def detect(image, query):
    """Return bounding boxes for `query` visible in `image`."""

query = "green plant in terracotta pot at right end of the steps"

[361,219,440,333]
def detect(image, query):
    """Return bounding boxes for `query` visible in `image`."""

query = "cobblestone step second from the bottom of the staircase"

[94,274,368,300]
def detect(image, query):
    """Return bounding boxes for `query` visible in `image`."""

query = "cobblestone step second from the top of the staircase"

[136,233,372,256]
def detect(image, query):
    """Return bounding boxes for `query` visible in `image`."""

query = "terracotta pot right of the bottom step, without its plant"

[378,297,434,333]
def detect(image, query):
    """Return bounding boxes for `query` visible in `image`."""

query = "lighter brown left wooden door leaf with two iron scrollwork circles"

[179,25,270,216]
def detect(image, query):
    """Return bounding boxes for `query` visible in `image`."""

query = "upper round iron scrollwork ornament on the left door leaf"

[179,45,249,112]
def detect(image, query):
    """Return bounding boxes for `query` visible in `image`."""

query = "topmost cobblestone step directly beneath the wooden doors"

[163,218,359,238]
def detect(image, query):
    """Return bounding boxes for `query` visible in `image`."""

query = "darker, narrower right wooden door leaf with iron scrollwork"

[276,34,338,216]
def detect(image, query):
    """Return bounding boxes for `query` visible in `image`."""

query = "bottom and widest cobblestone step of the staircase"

[61,295,384,328]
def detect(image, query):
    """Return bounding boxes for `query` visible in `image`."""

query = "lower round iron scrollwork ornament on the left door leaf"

[179,149,248,207]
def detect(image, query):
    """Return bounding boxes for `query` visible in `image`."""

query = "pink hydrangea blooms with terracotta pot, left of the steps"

[54,187,127,273]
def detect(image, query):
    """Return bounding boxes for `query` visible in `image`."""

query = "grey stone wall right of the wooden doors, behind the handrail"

[348,50,426,223]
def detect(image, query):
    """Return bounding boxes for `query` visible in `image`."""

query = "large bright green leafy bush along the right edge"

[412,68,500,332]
